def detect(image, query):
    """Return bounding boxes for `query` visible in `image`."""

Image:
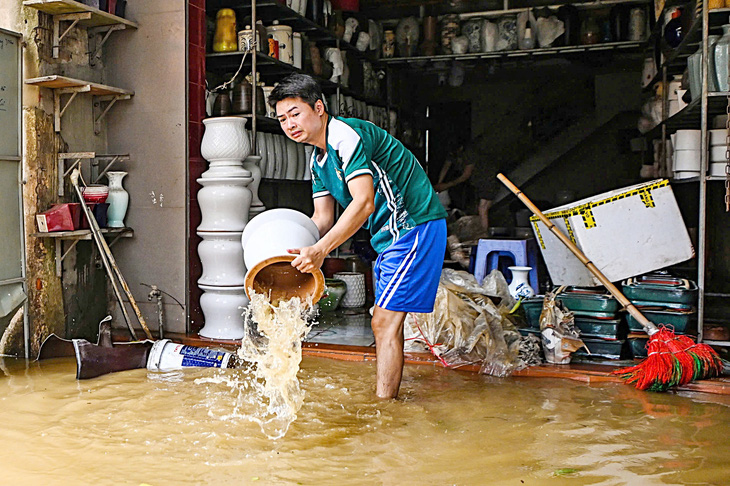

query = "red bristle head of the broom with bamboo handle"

[613,326,723,391]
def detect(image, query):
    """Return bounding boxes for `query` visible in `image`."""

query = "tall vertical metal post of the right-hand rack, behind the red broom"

[692,2,710,343]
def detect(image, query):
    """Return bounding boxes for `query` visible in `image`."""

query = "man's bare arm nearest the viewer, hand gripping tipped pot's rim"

[289,174,375,273]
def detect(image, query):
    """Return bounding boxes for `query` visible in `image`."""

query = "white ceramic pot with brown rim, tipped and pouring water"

[241,208,324,303]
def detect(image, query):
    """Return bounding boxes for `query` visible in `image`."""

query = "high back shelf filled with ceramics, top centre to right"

[372,1,651,68]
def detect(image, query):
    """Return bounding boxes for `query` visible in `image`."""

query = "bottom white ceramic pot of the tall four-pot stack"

[198,285,249,339]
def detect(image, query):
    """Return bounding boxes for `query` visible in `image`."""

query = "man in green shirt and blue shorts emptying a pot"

[269,74,446,398]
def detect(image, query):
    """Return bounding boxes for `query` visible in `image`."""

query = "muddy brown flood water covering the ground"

[0,358,730,486]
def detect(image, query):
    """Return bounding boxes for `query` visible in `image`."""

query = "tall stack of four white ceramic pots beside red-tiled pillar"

[197,116,255,339]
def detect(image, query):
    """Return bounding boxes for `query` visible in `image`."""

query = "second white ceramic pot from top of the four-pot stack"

[198,177,253,231]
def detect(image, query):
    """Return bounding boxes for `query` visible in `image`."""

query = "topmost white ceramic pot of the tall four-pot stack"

[200,116,251,178]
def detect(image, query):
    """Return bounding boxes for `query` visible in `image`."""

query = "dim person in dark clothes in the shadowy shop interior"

[434,135,499,230]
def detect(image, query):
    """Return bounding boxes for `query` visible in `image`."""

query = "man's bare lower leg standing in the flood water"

[372,305,406,398]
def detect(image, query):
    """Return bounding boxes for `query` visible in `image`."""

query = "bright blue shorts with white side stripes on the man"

[374,219,446,313]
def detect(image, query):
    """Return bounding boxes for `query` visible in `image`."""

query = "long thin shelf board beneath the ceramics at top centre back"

[380,41,646,67]
